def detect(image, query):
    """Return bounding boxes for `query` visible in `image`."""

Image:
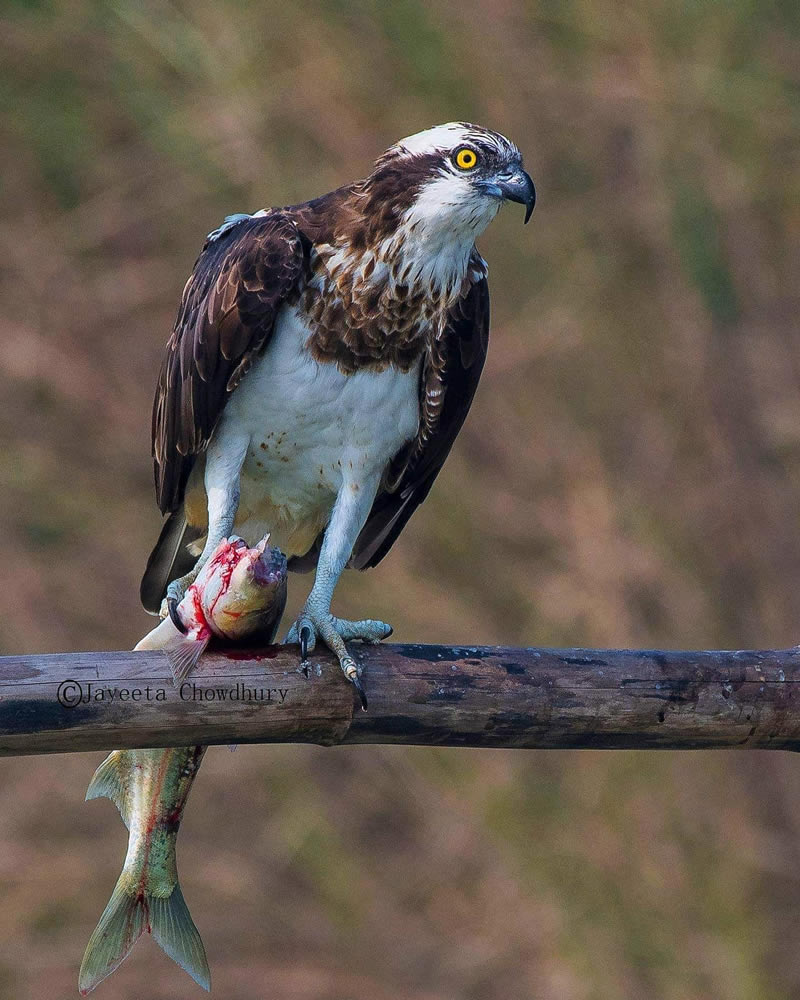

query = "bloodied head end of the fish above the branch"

[164,535,287,684]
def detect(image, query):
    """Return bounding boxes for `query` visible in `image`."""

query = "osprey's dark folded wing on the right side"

[350,274,489,569]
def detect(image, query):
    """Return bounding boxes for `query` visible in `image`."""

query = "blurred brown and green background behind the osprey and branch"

[0,0,800,1000]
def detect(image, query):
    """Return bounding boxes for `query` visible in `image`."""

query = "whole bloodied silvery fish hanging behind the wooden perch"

[78,536,287,996]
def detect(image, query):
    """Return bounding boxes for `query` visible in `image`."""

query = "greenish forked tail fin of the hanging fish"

[78,873,211,996]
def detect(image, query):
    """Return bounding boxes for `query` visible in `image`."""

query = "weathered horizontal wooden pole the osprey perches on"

[0,644,800,754]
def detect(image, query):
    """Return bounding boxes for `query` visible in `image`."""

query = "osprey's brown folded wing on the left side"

[153,212,305,514]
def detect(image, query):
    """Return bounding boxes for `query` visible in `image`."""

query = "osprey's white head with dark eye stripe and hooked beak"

[373,122,536,239]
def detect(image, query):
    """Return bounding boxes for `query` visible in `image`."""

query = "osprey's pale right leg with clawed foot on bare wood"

[286,478,392,709]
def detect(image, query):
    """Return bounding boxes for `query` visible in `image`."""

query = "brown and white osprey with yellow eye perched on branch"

[141,122,535,707]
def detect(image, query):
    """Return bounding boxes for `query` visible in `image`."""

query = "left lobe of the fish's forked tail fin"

[78,882,148,996]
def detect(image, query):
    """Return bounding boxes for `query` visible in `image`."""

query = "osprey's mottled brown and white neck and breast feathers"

[301,164,490,374]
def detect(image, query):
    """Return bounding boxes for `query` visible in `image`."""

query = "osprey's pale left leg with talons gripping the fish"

[162,427,250,632]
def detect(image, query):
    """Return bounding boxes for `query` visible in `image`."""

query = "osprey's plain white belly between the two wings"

[206,306,419,555]
